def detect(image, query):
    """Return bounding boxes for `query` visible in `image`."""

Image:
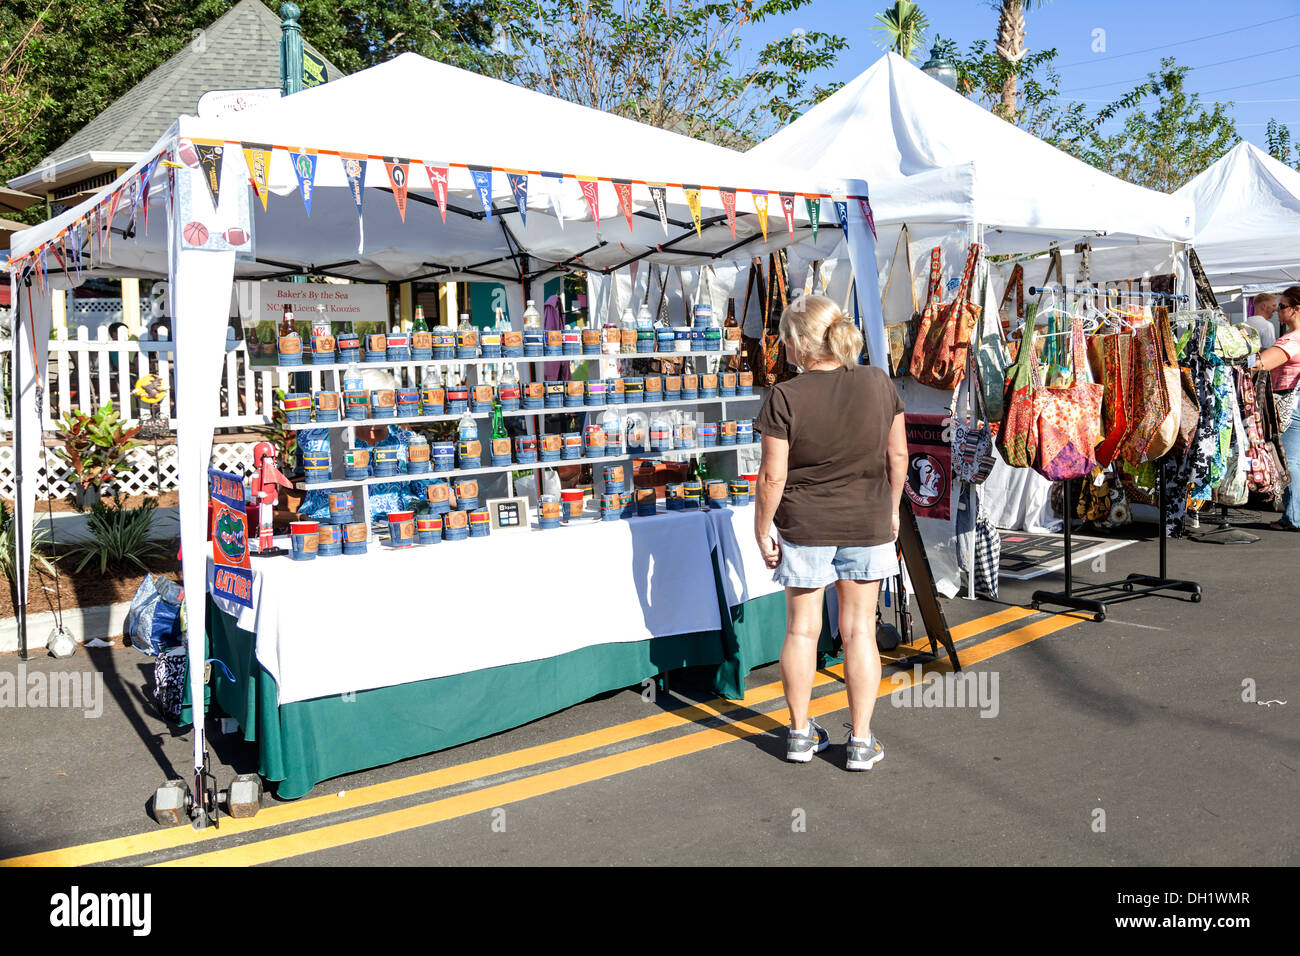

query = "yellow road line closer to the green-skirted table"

[0,607,1034,866]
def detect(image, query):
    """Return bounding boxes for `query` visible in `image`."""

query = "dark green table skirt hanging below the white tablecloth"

[197,554,831,800]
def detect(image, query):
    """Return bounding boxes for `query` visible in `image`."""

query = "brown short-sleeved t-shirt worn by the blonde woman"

[754,365,902,548]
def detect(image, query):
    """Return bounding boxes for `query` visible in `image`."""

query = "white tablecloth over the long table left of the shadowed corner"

[209,511,728,704]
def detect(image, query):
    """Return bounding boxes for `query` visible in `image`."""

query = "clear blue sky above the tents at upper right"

[755,0,1300,146]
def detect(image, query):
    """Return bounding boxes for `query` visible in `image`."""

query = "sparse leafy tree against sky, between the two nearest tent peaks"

[495,0,848,147]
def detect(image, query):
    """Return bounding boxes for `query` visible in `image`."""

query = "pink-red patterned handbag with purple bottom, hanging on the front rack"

[1032,316,1102,481]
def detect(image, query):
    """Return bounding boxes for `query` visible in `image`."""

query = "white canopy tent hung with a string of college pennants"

[10,53,884,816]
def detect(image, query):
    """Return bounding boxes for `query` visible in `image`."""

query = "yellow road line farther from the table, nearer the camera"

[155,615,1087,866]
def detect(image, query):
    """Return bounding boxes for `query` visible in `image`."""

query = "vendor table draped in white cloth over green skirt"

[201,506,831,799]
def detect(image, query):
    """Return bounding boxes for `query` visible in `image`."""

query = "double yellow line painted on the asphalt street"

[0,607,1083,866]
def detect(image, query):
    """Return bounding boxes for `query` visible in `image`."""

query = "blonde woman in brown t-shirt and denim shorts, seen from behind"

[754,295,907,770]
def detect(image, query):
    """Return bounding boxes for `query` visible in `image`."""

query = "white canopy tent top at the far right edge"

[1174,142,1300,295]
